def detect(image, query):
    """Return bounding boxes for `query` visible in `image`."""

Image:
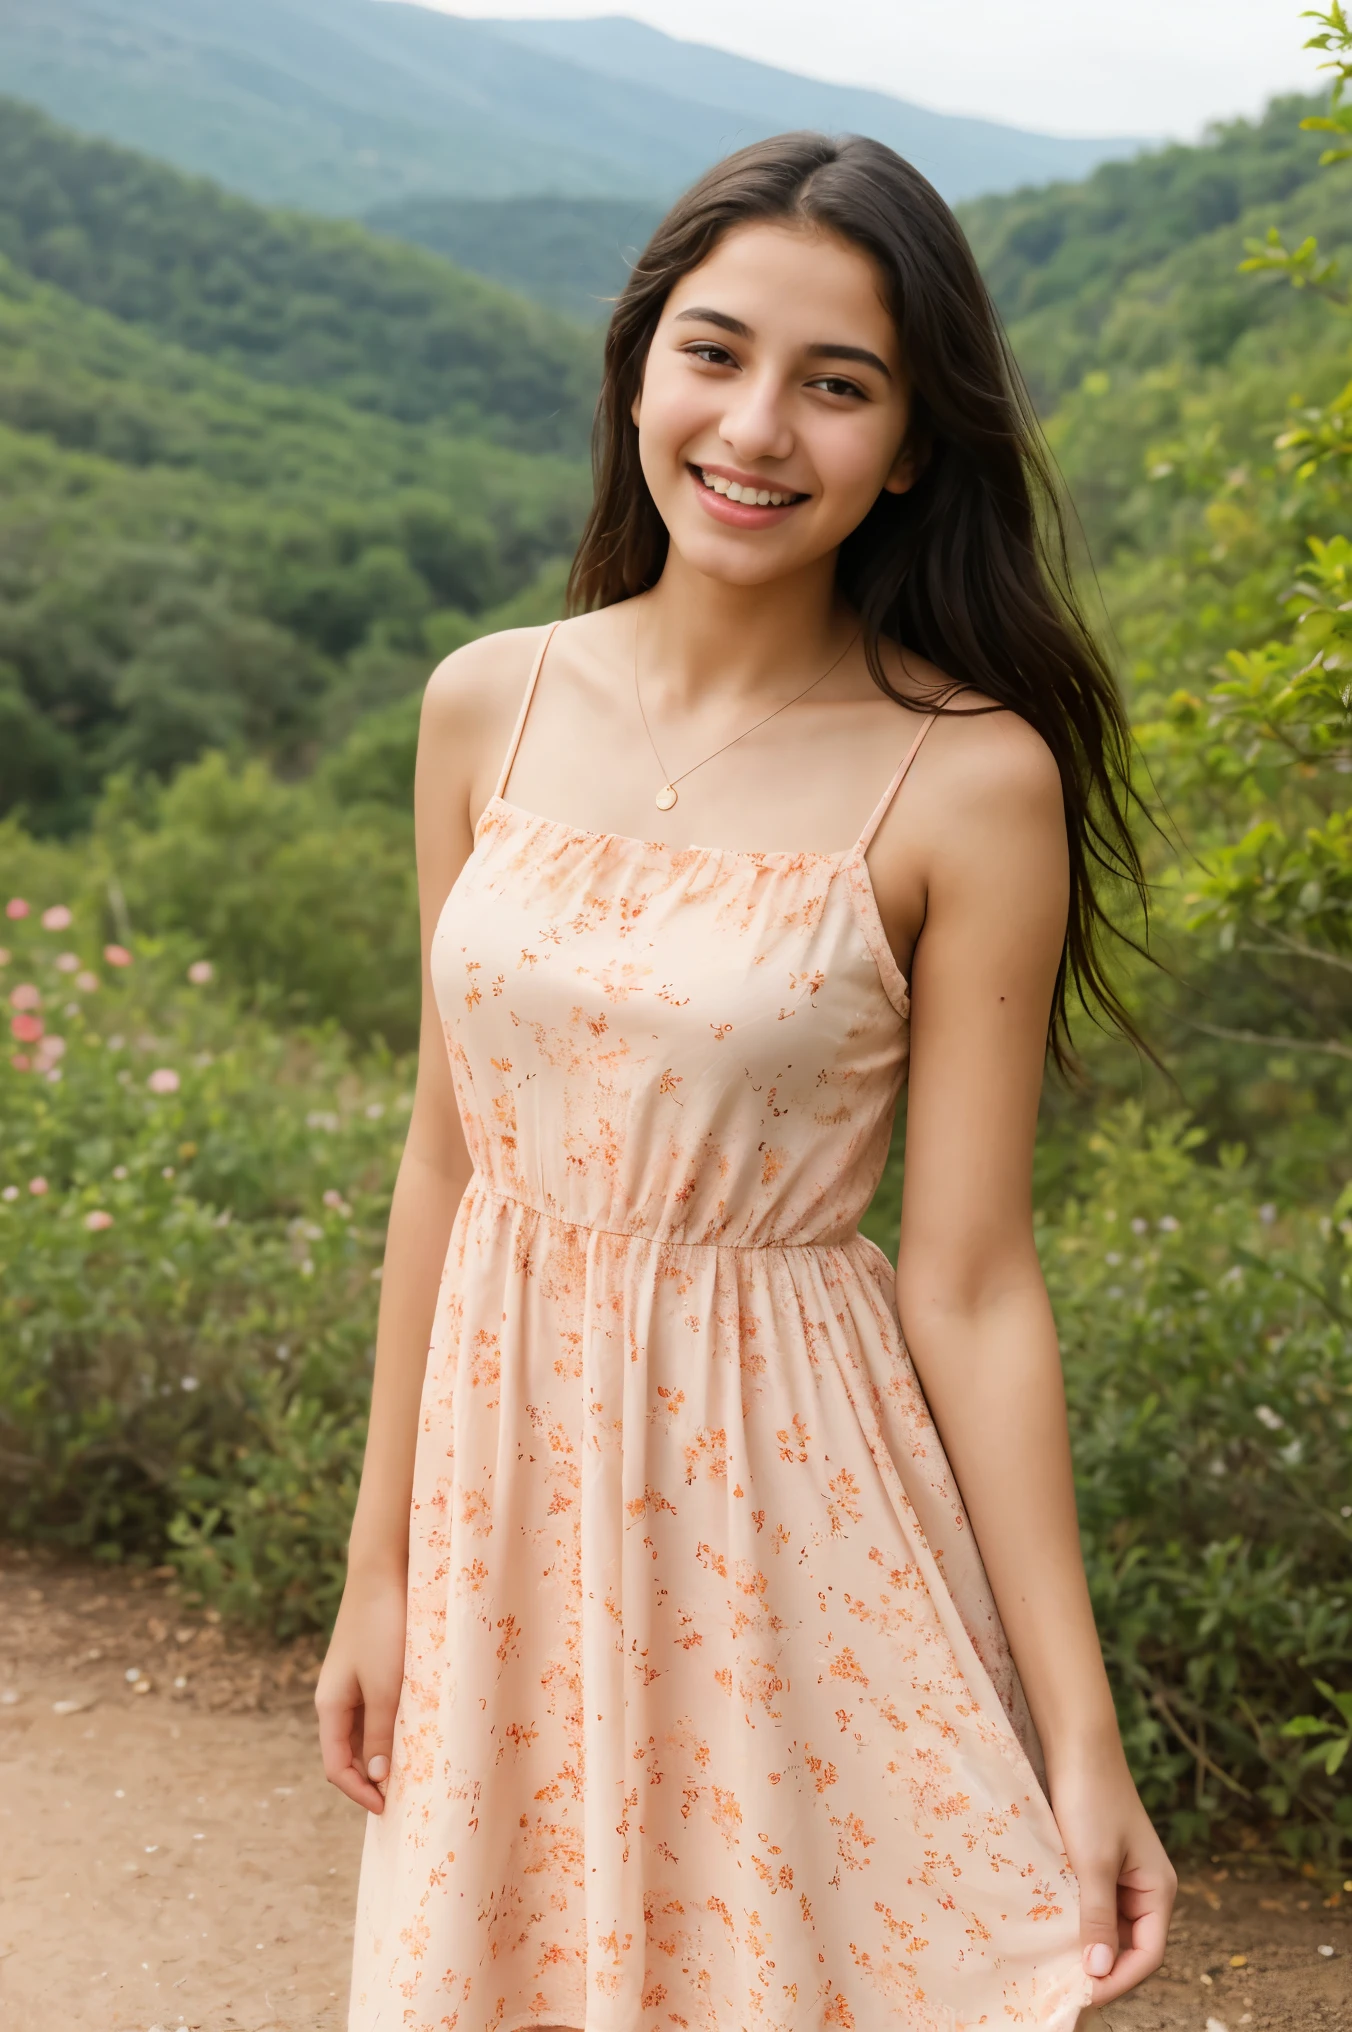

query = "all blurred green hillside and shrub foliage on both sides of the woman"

[0,8,1352,1871]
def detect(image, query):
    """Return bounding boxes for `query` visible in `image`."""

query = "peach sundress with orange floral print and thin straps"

[350,625,1088,2032]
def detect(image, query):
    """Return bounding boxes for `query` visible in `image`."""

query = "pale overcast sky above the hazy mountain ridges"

[423,0,1319,140]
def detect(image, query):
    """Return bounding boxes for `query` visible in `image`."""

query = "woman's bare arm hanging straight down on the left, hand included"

[315,632,544,1813]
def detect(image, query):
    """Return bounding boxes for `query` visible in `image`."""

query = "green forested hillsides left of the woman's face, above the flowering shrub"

[0,104,592,829]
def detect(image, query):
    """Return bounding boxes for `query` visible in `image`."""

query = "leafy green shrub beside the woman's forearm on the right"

[1041,1109,1352,1861]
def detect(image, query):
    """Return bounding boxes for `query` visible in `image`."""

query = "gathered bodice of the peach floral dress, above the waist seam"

[431,799,907,1248]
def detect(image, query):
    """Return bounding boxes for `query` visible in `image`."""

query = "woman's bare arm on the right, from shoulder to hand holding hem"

[874,715,1173,2004]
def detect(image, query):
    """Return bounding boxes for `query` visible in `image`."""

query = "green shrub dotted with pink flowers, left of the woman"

[0,910,409,1628]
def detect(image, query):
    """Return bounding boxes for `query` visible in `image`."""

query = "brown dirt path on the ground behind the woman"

[0,1552,1352,2032]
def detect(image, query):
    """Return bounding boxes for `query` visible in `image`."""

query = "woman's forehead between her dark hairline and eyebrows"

[663,219,899,366]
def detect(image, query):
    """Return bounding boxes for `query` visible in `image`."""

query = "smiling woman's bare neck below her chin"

[638,551,848,707]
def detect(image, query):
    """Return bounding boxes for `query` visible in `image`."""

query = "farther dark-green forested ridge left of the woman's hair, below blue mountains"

[0,100,594,451]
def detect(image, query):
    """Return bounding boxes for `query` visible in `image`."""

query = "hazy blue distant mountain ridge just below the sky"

[0,0,1136,215]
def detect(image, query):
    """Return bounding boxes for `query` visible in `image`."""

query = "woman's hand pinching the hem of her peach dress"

[1049,1748,1179,2006]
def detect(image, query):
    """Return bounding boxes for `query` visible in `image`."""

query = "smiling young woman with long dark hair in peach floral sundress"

[319,134,1173,2032]
